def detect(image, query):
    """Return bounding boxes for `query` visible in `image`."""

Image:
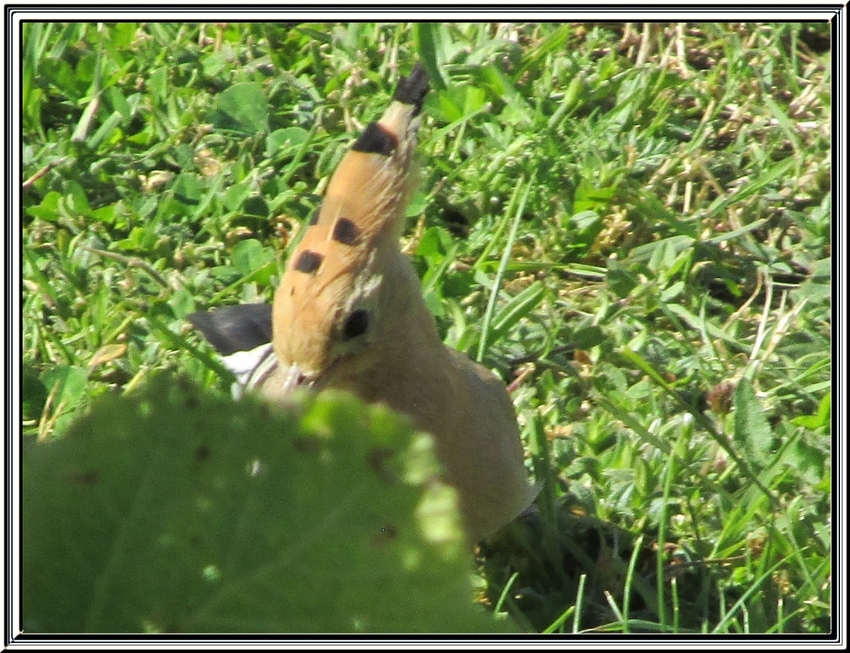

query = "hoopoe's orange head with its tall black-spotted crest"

[273,64,428,384]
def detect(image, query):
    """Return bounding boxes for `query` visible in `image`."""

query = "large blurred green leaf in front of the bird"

[23,379,505,633]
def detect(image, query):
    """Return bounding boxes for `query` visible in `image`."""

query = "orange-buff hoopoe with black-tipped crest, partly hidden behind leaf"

[189,64,536,543]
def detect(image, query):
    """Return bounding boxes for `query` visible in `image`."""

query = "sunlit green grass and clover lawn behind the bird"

[22,23,833,634]
